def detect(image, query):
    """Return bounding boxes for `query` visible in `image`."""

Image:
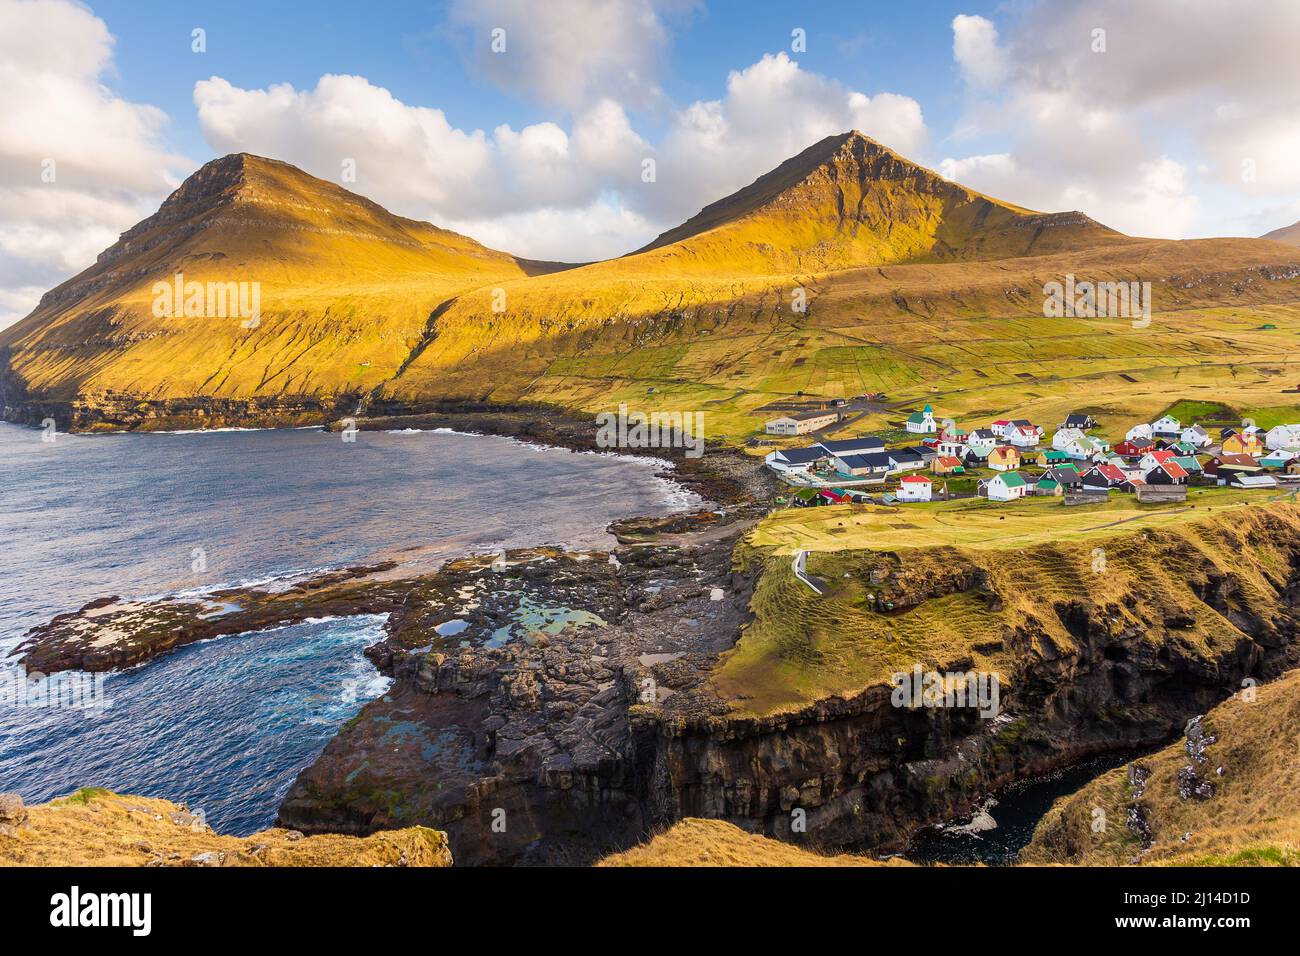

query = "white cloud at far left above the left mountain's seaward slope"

[0,0,192,326]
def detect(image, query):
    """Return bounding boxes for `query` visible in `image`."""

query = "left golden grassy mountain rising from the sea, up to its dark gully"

[0,153,561,411]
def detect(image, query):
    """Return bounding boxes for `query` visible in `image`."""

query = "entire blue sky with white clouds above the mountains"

[0,0,1300,326]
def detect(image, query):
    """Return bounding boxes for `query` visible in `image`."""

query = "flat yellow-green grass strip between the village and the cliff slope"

[749,488,1291,554]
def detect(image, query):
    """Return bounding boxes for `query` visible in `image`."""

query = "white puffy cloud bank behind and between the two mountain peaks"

[194,53,926,260]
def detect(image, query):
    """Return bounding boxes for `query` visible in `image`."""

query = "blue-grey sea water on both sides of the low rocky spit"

[0,423,699,834]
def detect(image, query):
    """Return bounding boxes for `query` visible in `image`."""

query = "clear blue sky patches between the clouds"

[90,0,996,157]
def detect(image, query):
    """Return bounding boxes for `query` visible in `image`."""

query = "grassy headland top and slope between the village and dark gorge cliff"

[712,502,1300,714]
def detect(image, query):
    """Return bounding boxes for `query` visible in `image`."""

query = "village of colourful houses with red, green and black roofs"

[764,405,1300,507]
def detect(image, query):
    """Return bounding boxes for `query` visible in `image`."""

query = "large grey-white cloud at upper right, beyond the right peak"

[948,0,1300,237]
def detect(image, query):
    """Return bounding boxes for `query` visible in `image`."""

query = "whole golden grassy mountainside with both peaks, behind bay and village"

[0,133,1300,442]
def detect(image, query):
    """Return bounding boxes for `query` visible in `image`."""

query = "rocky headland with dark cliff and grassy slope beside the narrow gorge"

[281,502,1300,864]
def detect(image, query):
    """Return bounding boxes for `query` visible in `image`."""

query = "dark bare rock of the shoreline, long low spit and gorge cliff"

[10,403,1300,865]
